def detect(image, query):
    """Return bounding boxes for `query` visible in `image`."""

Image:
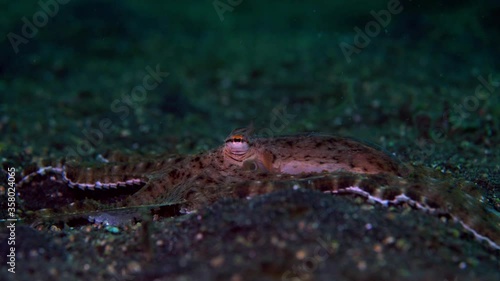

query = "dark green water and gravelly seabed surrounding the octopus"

[0,0,500,281]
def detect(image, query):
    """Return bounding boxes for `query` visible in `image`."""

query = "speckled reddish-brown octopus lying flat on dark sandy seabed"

[18,128,500,250]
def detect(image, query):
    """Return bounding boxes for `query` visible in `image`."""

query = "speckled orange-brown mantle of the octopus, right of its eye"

[226,135,400,175]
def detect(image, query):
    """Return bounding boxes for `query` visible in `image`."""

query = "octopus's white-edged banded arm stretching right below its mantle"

[227,172,500,250]
